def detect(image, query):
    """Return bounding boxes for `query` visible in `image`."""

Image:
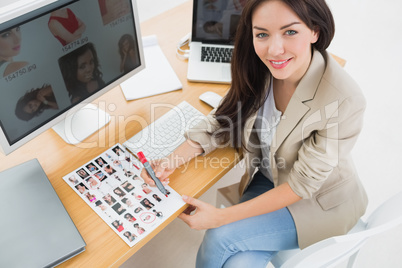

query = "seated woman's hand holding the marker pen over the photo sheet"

[141,158,176,186]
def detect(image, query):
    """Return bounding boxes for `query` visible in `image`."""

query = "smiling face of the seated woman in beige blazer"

[252,0,318,83]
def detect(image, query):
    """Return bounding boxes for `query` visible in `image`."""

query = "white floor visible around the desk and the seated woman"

[121,0,402,268]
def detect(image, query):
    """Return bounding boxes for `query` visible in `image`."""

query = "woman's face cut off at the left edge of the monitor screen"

[0,27,21,61]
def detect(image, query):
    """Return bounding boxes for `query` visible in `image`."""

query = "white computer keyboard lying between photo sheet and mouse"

[123,101,205,159]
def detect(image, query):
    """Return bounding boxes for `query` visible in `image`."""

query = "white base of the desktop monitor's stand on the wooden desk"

[53,103,110,144]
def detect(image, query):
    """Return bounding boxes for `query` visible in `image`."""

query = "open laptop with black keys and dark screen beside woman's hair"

[187,0,246,83]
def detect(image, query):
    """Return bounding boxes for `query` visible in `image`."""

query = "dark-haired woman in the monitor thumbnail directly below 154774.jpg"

[59,43,105,103]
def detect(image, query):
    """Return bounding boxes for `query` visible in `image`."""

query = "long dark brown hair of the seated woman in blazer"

[214,0,335,149]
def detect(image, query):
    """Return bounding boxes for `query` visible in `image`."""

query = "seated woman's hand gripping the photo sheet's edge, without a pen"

[179,196,223,230]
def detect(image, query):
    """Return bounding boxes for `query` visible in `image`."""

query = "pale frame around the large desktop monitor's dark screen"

[0,0,145,155]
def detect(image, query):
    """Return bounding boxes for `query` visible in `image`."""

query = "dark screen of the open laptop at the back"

[191,0,247,44]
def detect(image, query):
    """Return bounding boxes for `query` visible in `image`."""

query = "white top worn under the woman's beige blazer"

[254,79,282,181]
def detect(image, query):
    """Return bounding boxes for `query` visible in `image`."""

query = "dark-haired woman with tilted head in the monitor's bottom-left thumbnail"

[15,84,59,121]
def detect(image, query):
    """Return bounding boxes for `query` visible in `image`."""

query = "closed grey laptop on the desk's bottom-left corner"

[0,159,86,267]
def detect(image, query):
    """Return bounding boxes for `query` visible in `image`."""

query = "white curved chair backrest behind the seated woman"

[281,191,402,268]
